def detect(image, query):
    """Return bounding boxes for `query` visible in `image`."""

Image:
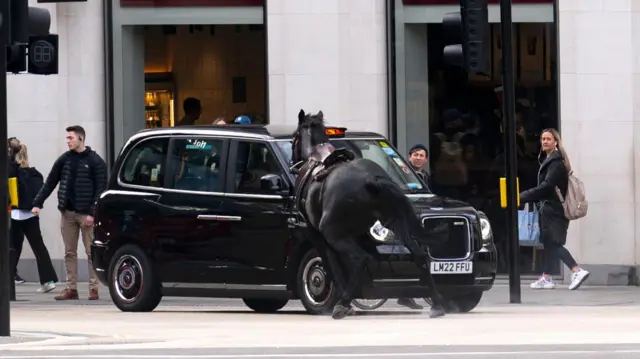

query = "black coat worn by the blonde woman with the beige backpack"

[520,151,569,245]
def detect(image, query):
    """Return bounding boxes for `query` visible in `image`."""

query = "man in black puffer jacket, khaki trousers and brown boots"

[32,126,107,300]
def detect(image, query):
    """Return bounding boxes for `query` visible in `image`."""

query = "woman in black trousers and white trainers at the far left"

[9,137,58,293]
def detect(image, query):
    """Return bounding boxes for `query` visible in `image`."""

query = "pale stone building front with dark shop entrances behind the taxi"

[9,0,640,284]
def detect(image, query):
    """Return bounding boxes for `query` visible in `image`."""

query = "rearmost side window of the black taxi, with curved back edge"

[120,138,169,187]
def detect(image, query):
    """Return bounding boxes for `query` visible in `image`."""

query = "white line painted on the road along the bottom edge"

[0,349,640,359]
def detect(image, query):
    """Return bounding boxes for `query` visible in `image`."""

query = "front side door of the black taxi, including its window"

[219,139,292,286]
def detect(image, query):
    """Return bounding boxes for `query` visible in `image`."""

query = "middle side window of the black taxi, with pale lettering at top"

[169,137,224,192]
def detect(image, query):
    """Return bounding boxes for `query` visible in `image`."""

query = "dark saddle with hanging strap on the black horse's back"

[295,148,356,224]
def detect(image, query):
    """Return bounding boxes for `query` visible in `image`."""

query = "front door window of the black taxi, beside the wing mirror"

[235,141,282,194]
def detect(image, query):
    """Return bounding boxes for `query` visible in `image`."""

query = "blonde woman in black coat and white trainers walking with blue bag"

[520,128,589,290]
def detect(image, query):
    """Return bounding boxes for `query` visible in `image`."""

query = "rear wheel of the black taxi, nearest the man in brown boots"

[109,244,162,312]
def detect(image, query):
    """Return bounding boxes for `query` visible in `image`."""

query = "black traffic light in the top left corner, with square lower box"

[6,0,58,75]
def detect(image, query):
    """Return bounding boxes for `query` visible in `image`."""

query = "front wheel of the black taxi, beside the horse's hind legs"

[296,248,340,315]
